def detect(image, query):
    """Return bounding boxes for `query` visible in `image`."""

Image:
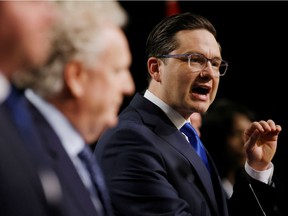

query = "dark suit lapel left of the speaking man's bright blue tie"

[131,94,225,215]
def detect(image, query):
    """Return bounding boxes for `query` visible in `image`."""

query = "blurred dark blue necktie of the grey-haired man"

[78,145,112,216]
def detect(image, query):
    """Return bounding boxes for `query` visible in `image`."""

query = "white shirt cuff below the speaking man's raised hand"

[245,161,274,185]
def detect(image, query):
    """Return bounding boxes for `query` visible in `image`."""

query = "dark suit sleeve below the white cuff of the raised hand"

[228,169,288,216]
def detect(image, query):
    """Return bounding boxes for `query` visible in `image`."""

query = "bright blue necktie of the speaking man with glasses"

[180,122,210,172]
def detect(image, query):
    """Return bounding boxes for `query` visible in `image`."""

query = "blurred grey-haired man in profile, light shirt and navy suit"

[15,1,134,216]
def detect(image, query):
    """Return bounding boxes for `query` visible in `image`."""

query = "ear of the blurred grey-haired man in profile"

[64,61,87,97]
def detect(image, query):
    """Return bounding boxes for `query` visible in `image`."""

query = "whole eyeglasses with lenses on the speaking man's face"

[157,53,228,77]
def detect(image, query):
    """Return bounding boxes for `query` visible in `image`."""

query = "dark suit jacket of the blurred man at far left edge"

[0,105,59,216]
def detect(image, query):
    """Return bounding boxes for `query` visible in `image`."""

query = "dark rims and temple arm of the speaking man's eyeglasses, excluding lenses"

[156,52,228,76]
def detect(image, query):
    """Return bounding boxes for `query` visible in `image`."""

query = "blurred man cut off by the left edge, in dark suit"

[0,1,61,216]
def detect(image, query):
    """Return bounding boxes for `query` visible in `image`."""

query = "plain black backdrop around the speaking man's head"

[120,1,288,182]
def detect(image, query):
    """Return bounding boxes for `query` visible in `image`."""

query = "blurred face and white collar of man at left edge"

[0,0,57,98]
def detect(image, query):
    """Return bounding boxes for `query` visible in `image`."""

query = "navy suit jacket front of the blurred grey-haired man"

[29,102,96,215]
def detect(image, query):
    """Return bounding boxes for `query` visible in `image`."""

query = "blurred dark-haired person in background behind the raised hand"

[200,99,256,198]
